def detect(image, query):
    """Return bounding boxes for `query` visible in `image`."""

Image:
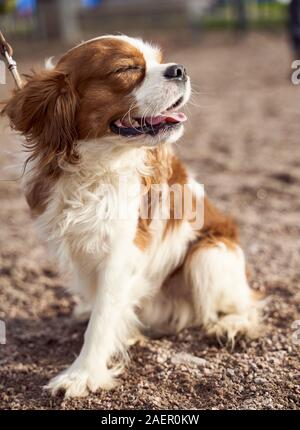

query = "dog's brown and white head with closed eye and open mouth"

[5,36,190,165]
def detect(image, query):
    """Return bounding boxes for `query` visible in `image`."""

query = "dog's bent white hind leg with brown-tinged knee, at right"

[184,237,259,343]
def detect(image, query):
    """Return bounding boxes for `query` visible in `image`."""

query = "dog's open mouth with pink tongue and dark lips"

[110,100,187,137]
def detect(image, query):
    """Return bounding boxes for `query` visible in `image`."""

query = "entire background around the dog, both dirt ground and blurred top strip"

[0,0,300,409]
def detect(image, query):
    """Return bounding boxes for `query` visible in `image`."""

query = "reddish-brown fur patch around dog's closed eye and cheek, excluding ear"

[57,38,146,139]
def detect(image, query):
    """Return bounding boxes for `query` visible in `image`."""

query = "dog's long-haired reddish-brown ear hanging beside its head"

[2,70,78,165]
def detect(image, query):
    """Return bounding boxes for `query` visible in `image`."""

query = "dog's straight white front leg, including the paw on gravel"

[47,240,141,397]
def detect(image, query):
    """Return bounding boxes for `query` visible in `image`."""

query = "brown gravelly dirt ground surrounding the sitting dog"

[0,34,300,409]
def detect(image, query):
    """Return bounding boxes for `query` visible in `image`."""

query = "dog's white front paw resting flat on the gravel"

[45,366,117,398]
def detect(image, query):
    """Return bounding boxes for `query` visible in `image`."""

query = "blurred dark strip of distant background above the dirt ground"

[0,0,296,41]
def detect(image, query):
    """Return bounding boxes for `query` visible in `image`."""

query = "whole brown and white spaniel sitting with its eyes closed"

[4,36,259,397]
